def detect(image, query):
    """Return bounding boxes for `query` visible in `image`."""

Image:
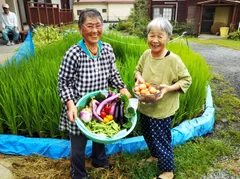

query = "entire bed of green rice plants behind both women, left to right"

[0,30,211,138]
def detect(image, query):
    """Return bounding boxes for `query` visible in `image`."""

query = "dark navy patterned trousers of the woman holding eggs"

[140,114,175,172]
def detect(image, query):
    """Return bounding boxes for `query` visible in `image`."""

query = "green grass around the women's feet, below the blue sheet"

[86,138,231,179]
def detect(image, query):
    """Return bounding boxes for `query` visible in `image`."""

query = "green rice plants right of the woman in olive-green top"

[168,41,212,125]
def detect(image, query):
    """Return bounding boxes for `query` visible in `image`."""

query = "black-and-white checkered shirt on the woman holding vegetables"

[58,42,125,135]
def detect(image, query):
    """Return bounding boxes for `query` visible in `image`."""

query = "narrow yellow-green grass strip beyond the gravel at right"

[188,37,240,50]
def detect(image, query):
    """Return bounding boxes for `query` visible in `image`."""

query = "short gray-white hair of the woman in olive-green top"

[147,17,173,35]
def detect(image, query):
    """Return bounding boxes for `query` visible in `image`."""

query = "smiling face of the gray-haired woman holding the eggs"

[147,28,170,54]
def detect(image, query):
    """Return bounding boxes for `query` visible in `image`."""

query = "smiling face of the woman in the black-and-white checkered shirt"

[79,17,103,45]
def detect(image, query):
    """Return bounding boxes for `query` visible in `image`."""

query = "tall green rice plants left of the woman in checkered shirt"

[0,34,80,137]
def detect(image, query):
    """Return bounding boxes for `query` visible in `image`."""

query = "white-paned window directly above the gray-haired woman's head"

[153,7,175,21]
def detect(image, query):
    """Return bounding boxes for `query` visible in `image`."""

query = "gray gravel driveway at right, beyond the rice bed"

[189,42,240,97]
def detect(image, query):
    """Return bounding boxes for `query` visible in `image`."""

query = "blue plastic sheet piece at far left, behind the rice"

[2,30,34,66]
